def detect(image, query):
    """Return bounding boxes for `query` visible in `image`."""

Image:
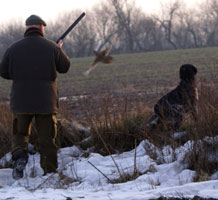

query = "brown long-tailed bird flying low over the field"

[83,45,113,76]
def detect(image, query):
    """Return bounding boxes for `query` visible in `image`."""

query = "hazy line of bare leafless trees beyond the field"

[0,0,218,57]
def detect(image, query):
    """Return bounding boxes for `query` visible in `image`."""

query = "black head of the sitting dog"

[179,64,198,81]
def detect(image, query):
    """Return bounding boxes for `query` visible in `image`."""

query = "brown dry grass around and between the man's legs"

[0,100,84,158]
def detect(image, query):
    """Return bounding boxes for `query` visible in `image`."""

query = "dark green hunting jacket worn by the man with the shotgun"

[0,28,70,114]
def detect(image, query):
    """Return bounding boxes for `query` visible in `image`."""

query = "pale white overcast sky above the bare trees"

[0,0,204,23]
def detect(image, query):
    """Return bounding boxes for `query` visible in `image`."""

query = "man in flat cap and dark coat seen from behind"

[0,15,70,179]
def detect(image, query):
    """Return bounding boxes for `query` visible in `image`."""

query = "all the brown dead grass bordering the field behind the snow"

[0,79,218,181]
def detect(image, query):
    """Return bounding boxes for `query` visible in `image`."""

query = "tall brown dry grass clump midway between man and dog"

[78,94,152,155]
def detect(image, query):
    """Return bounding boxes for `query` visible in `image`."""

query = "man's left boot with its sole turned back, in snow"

[12,151,28,180]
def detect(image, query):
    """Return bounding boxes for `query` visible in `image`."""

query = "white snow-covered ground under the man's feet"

[0,141,218,200]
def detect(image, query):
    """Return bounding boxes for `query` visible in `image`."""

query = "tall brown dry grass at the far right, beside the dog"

[181,82,218,181]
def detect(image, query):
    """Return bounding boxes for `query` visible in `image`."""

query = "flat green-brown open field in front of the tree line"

[0,47,218,101]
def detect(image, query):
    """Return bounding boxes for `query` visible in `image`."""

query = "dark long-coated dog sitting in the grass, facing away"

[147,64,198,130]
